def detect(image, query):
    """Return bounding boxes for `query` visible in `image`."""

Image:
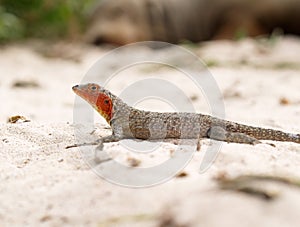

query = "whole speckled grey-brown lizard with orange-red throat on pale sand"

[72,83,300,149]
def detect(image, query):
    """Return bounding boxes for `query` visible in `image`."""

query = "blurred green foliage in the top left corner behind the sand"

[0,0,95,43]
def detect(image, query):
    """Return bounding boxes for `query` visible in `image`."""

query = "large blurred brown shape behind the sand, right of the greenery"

[86,0,300,45]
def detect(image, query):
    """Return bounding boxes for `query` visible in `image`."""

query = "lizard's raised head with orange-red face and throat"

[72,83,113,124]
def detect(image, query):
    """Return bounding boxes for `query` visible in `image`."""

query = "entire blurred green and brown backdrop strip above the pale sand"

[0,0,300,45]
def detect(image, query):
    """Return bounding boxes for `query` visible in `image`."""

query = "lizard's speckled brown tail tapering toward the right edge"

[226,122,300,143]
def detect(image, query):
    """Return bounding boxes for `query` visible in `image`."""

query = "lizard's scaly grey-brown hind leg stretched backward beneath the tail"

[207,126,261,145]
